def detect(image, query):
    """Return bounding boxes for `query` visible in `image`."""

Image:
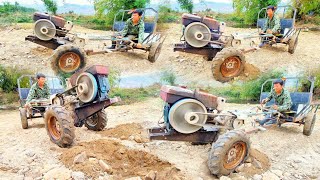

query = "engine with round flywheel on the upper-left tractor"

[33,12,73,41]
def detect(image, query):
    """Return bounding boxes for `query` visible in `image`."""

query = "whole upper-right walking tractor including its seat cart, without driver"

[174,6,301,82]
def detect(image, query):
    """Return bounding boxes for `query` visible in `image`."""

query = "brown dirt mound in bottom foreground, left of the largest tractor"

[60,139,182,179]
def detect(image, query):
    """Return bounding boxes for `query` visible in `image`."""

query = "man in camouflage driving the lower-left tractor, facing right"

[25,73,50,108]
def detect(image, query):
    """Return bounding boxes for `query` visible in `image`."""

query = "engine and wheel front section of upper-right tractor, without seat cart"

[174,14,245,82]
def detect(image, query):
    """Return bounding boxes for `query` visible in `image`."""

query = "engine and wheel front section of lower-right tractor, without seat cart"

[149,86,250,176]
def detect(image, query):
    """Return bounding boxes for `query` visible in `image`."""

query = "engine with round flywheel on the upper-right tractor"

[182,14,225,48]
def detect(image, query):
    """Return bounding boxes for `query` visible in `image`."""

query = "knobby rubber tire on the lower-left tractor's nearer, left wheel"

[44,105,75,148]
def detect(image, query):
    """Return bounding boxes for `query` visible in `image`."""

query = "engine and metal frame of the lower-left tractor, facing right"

[53,65,121,127]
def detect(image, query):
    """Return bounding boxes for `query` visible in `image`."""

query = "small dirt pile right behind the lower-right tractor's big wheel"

[235,148,270,177]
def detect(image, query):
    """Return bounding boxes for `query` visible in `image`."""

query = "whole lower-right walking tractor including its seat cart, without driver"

[149,78,319,176]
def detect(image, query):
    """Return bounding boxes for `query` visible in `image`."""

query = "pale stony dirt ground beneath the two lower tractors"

[0,98,320,179]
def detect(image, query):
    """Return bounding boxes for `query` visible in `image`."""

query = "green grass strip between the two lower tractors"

[109,84,160,105]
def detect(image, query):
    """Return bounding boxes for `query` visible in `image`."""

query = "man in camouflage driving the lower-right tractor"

[259,79,292,126]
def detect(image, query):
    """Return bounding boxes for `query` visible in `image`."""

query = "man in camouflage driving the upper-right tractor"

[260,6,281,47]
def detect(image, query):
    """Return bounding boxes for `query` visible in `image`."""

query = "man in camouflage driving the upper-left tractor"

[109,9,144,49]
